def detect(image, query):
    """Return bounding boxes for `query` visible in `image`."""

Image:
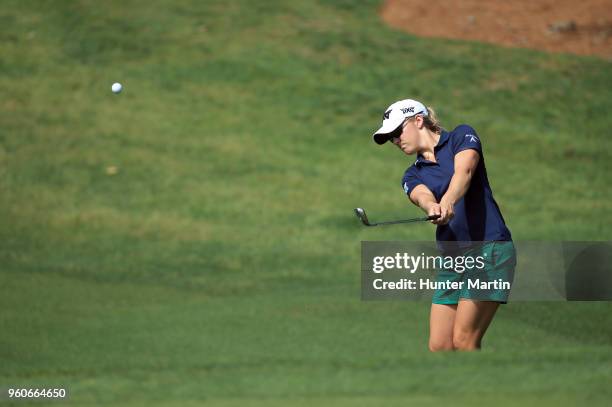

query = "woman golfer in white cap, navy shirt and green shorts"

[373,99,516,351]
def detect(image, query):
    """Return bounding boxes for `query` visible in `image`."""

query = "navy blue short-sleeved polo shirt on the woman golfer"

[402,124,512,249]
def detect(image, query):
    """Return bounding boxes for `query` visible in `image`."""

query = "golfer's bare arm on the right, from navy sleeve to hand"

[434,149,480,225]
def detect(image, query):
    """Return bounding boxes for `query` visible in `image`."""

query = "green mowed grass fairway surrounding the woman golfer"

[0,0,612,406]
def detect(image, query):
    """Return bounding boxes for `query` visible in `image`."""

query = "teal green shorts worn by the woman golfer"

[432,242,516,304]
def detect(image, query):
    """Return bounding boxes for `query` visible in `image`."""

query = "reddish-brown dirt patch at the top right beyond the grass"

[381,0,612,60]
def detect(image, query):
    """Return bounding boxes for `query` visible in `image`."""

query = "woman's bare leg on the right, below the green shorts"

[452,299,499,350]
